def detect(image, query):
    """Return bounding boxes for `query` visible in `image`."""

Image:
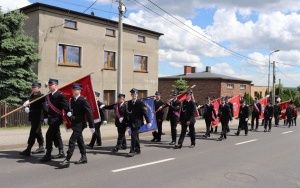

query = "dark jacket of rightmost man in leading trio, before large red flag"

[70,96,95,131]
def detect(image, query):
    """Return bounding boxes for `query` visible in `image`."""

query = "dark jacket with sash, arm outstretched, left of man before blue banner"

[104,102,128,127]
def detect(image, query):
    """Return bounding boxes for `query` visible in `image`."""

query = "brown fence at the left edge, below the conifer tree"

[0,103,30,127]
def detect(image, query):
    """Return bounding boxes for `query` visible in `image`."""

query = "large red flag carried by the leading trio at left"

[59,75,101,129]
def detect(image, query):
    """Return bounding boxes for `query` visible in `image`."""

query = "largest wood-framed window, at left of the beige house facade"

[58,44,81,66]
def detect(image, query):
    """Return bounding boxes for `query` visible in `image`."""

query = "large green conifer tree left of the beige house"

[0,10,39,105]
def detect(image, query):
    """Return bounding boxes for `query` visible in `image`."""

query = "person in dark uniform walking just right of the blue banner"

[151,92,165,142]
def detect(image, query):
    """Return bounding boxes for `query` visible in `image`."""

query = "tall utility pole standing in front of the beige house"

[117,0,126,95]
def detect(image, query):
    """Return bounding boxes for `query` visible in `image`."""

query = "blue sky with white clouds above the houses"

[0,0,300,87]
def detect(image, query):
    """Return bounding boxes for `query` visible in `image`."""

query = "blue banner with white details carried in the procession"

[139,98,157,133]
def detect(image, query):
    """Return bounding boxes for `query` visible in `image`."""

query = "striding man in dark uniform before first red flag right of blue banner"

[175,92,196,148]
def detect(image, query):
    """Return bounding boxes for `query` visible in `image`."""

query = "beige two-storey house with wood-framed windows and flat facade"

[21,3,162,104]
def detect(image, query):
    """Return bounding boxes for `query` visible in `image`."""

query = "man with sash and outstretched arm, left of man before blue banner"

[104,94,128,152]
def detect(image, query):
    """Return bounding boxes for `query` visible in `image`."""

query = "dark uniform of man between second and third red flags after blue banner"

[218,103,232,140]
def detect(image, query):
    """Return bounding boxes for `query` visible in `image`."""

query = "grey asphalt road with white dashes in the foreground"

[0,122,300,188]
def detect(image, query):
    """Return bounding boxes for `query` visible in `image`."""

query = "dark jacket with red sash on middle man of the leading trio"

[44,90,70,118]
